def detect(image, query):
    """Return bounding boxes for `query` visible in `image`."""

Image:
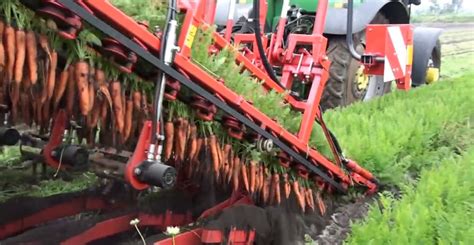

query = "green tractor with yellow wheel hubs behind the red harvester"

[216,0,441,109]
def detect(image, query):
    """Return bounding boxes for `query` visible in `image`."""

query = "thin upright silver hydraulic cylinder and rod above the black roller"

[151,0,176,144]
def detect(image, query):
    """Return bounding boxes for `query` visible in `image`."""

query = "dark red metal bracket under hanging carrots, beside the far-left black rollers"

[43,110,67,169]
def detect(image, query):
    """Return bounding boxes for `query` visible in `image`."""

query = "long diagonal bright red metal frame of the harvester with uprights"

[78,0,376,189]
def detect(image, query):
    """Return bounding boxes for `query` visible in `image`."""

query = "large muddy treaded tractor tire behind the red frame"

[321,13,391,111]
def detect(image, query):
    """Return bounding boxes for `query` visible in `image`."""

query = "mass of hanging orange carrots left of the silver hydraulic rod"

[0,0,152,147]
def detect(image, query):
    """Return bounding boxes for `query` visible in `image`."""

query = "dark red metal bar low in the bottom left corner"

[0,196,117,239]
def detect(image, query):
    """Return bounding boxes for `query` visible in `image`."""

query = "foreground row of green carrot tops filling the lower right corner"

[347,145,474,244]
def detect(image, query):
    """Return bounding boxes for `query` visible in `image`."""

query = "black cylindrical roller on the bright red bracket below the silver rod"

[135,160,176,189]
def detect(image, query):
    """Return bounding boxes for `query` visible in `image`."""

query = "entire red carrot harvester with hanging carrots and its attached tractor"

[0,0,441,245]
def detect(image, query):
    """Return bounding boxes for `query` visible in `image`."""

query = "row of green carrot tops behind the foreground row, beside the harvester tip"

[322,73,474,185]
